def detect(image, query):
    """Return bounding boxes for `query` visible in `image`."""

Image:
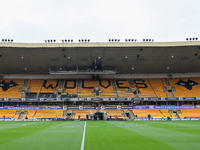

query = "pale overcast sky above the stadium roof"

[0,0,200,43]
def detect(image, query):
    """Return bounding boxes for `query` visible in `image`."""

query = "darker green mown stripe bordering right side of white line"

[85,121,175,150]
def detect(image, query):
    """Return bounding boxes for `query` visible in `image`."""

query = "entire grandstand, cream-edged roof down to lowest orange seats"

[0,41,200,120]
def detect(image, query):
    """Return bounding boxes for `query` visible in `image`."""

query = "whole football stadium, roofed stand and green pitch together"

[0,39,200,150]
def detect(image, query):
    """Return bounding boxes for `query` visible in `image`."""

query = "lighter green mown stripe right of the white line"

[110,121,200,150]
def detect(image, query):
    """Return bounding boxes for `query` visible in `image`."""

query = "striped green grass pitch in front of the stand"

[0,121,200,150]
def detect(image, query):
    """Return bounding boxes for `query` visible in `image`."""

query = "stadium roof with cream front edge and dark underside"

[0,41,200,74]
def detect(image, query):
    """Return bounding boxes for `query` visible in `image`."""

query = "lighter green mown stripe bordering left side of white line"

[0,121,84,150]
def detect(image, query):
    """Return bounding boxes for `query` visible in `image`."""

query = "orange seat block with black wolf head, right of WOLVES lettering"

[169,78,200,97]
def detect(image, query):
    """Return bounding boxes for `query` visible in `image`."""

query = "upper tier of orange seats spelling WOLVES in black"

[0,77,200,98]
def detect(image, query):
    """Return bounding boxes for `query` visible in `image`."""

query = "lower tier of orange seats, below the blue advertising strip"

[0,109,200,120]
